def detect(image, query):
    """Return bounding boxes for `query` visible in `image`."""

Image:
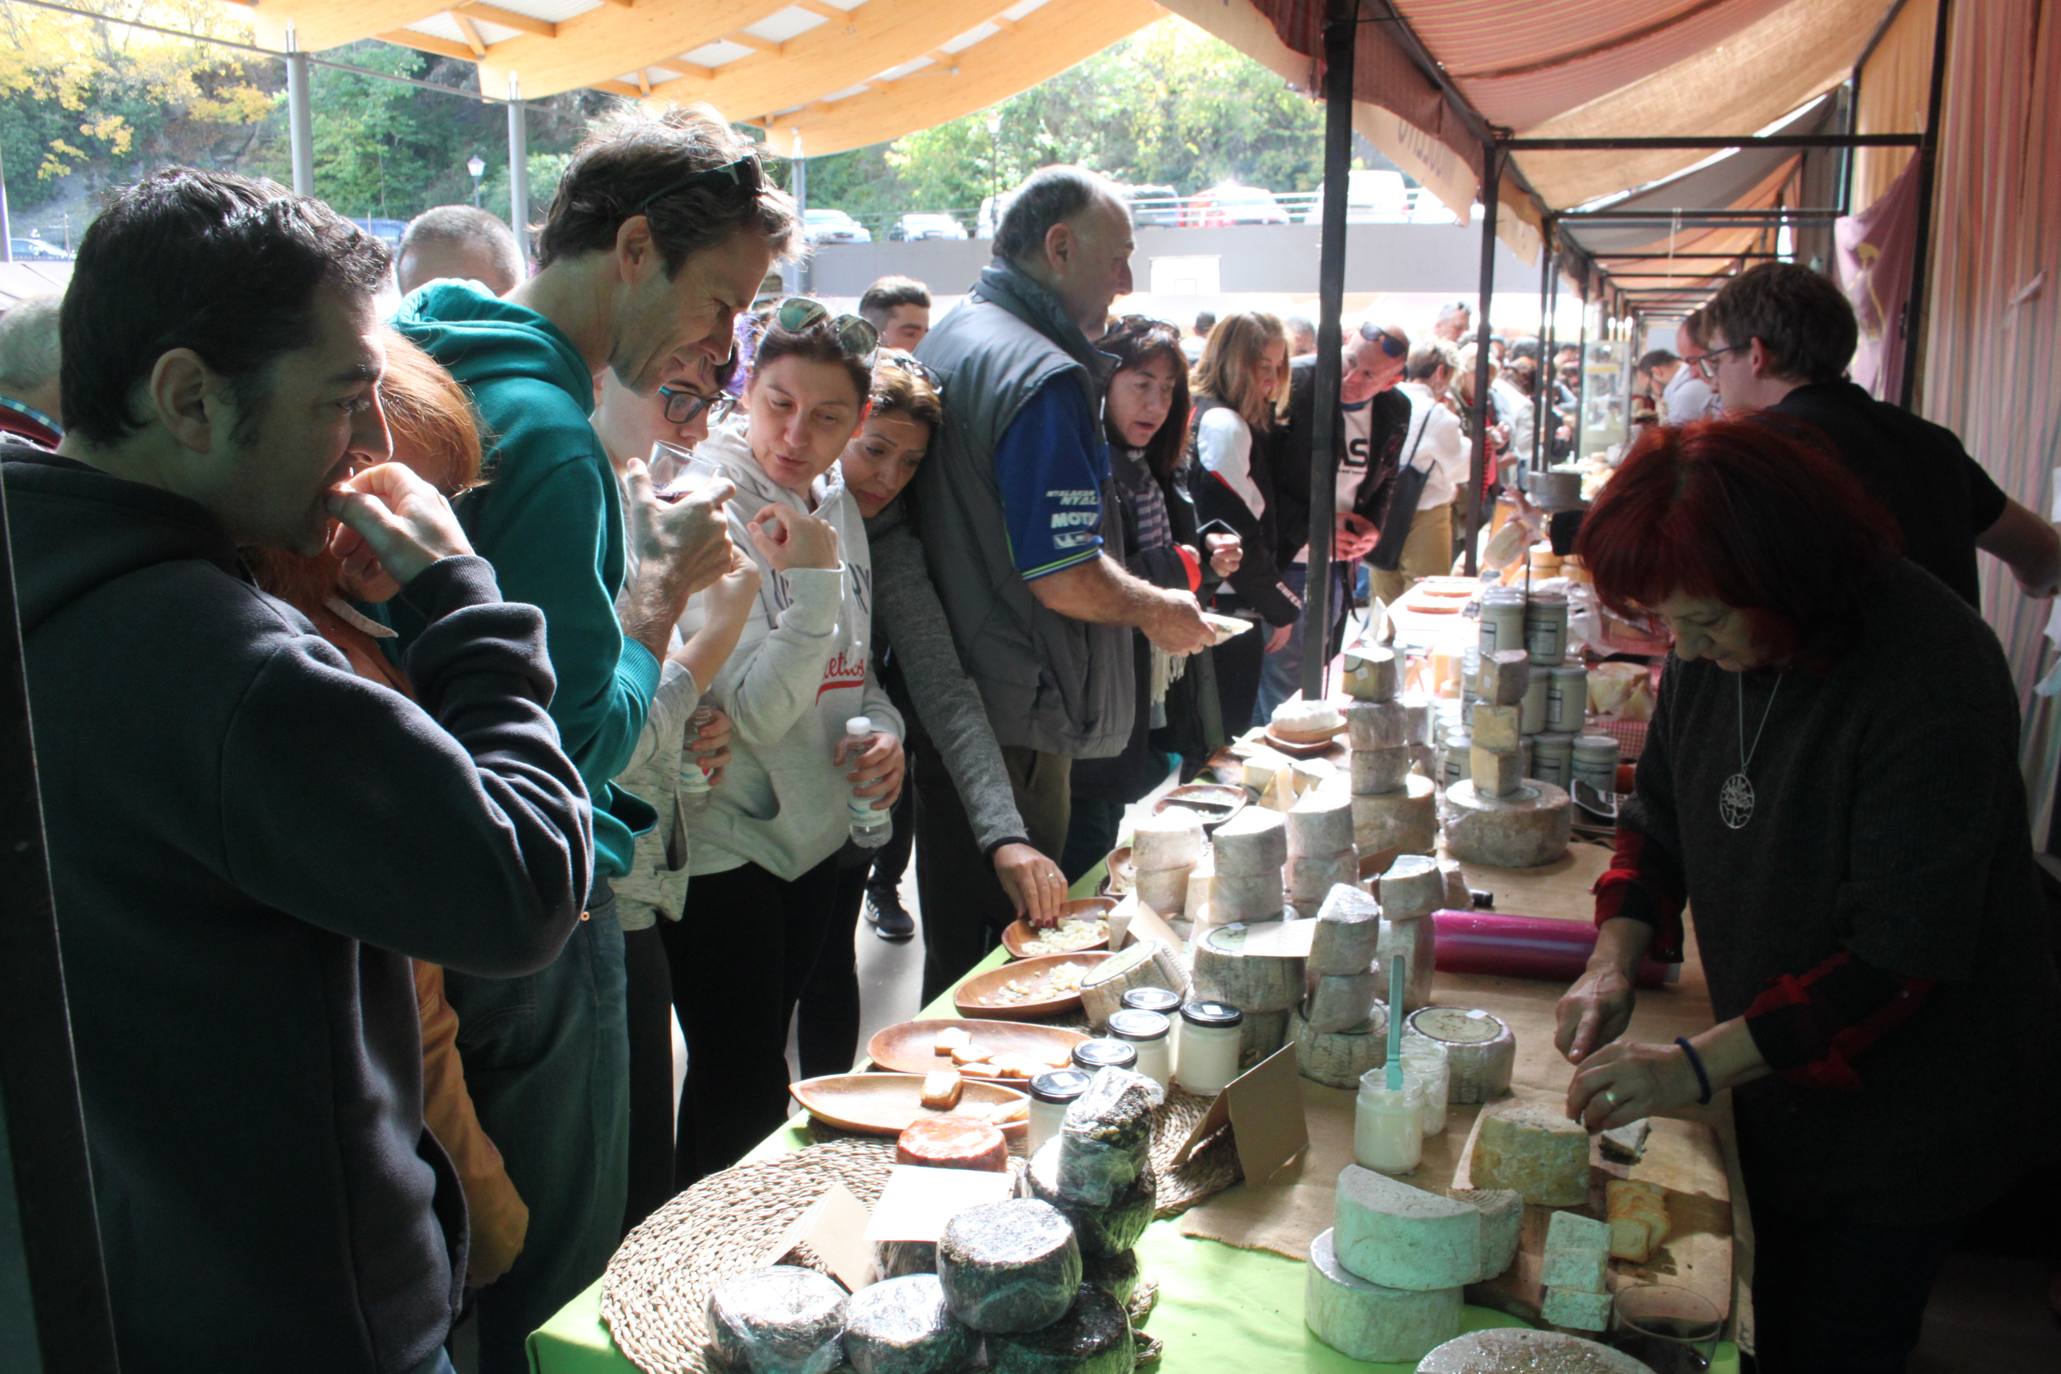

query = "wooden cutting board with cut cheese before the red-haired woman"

[1453,1092,1731,1320]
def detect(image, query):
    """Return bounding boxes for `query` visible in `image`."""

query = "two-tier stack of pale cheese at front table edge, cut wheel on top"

[1303,1164,1523,1362]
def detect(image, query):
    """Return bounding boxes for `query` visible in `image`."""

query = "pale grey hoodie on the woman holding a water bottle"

[680,422,903,880]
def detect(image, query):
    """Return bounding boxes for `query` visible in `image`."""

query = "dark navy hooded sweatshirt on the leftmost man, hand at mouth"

[0,445,592,1374]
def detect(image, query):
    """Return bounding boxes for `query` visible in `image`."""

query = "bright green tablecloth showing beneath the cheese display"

[530,867,1739,1374]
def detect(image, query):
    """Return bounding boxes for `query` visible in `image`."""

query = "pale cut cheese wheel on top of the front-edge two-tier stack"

[1331,1164,1482,1292]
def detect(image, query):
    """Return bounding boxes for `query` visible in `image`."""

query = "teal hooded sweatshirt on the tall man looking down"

[394,280,660,878]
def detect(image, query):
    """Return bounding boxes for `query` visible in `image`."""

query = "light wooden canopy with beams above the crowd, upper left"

[223,0,1164,157]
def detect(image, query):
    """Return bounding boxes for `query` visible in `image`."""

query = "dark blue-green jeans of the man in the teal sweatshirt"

[443,880,629,1374]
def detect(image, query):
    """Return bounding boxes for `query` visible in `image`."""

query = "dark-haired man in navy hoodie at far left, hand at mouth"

[0,169,594,1374]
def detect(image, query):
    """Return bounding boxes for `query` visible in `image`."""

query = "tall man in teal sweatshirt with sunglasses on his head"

[396,109,796,1374]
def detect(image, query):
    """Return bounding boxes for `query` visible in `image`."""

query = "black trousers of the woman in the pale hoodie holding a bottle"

[662,855,837,1189]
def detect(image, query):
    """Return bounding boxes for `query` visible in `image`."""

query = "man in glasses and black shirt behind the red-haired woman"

[1698,262,2061,608]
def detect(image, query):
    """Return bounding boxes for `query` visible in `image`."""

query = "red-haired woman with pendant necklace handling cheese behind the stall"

[1558,420,2061,1374]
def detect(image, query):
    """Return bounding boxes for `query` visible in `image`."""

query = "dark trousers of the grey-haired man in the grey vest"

[915,745,1079,1005]
